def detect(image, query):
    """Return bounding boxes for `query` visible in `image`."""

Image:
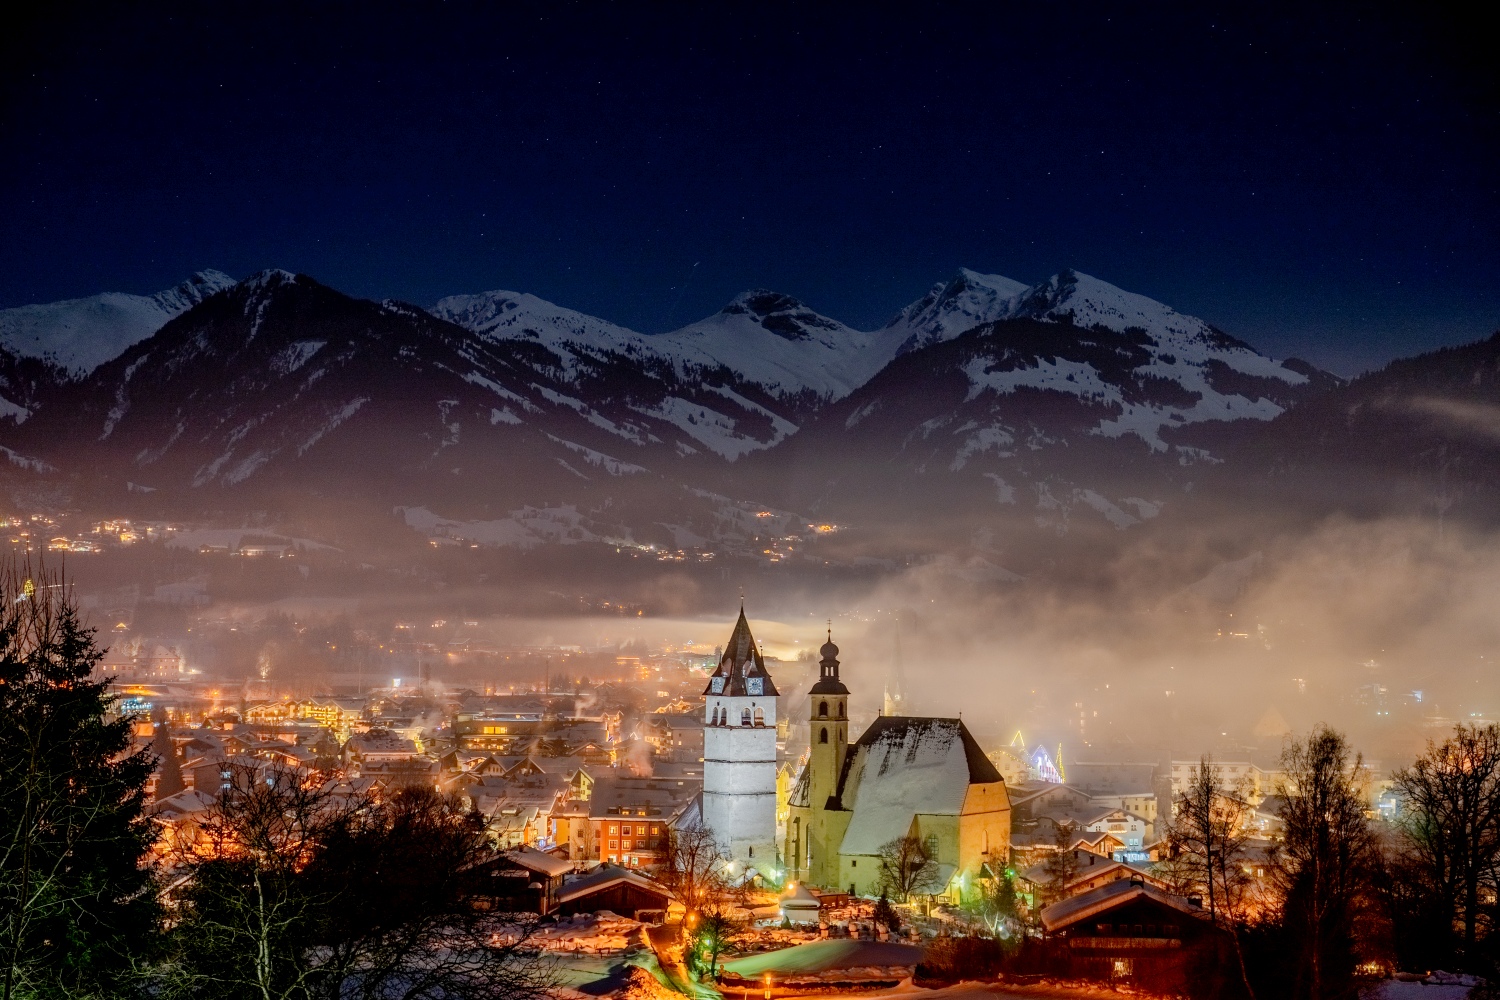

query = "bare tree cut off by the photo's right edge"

[1395,724,1500,963]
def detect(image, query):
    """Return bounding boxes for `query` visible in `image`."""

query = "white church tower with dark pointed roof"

[704,607,777,871]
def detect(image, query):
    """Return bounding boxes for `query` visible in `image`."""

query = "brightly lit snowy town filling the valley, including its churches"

[87,599,1467,994]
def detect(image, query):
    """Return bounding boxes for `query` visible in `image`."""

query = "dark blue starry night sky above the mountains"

[0,3,1500,373]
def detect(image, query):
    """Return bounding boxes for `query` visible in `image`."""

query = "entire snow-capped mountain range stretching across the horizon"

[0,262,1362,554]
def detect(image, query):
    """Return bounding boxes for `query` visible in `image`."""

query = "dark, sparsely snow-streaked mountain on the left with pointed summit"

[12,271,846,502]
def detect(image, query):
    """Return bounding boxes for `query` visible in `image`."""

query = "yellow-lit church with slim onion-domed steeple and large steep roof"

[786,632,1011,898]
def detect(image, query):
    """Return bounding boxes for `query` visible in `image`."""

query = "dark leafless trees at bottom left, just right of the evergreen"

[162,769,552,1000]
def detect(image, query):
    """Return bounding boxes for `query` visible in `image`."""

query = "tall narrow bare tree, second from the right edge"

[1272,726,1376,1000]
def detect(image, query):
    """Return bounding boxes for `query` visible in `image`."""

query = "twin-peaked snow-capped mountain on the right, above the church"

[744,271,1338,539]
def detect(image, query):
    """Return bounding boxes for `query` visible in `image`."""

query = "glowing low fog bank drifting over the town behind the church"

[170,520,1500,765]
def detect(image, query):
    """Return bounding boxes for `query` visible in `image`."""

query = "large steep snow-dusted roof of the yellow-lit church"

[839,715,1004,855]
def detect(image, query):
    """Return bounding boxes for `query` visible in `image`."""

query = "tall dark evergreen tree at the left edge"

[0,565,158,1000]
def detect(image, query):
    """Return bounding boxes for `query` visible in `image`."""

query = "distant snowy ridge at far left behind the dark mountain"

[0,270,234,378]
